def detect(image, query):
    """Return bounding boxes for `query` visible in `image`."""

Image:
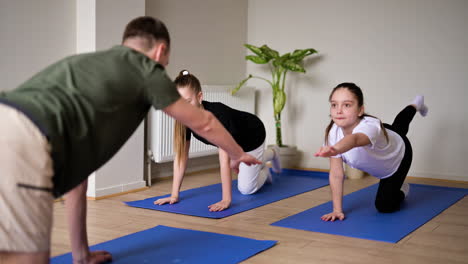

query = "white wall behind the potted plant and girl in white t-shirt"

[247,0,468,180]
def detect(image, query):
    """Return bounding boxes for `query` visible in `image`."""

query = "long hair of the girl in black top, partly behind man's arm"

[174,70,201,162]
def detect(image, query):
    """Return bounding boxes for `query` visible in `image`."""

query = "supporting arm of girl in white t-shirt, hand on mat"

[321,158,345,221]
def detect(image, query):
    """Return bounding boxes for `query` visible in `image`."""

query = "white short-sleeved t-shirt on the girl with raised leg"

[328,116,405,179]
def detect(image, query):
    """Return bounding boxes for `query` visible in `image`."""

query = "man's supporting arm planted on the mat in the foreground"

[65,180,112,264]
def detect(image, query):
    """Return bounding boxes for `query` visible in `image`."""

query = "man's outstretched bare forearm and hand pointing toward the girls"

[163,98,261,171]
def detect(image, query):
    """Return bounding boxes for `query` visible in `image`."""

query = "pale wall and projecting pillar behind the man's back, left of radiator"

[0,0,145,196]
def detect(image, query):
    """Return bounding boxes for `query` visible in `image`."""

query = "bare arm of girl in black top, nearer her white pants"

[208,149,232,212]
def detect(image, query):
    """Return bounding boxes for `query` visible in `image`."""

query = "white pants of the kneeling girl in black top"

[237,142,274,194]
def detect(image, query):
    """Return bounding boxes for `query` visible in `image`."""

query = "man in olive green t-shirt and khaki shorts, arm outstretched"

[0,17,259,263]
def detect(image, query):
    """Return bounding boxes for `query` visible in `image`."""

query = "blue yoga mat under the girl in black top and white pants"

[126,169,328,218]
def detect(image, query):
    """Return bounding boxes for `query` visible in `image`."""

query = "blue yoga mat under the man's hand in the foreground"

[50,225,277,264]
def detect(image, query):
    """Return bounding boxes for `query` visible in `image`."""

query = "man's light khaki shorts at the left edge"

[0,103,54,252]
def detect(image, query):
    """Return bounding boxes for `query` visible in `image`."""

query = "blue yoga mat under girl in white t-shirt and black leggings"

[272,184,468,243]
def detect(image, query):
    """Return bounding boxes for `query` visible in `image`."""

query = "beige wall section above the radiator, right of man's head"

[146,0,248,85]
